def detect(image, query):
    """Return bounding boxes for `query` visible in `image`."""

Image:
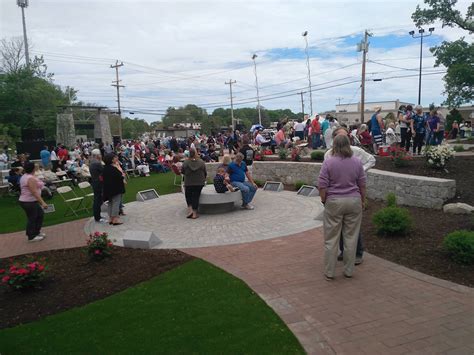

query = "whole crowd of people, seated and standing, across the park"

[1,105,470,281]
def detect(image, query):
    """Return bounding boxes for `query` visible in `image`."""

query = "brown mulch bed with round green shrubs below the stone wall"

[362,200,474,287]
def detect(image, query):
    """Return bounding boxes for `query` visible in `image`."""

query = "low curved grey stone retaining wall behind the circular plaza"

[206,161,456,209]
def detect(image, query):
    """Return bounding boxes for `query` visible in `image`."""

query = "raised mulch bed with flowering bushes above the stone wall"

[375,156,474,205]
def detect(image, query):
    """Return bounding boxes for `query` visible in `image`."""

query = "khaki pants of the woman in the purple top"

[324,197,362,277]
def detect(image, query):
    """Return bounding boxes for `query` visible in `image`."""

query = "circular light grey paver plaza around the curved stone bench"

[84,190,323,249]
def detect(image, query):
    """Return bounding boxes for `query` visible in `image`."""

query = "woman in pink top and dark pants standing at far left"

[19,162,48,242]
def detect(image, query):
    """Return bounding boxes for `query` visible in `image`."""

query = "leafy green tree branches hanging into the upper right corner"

[412,0,474,107]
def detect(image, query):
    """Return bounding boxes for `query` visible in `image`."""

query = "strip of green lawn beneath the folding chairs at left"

[0,172,179,233]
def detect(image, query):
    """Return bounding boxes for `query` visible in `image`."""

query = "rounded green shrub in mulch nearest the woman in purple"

[372,207,412,236]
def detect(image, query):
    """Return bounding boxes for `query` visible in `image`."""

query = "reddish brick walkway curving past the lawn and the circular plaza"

[0,220,474,354]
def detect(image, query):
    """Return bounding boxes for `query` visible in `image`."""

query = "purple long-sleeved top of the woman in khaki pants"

[318,156,366,199]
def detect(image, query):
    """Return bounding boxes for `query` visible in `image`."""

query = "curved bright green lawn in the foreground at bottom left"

[0,260,304,355]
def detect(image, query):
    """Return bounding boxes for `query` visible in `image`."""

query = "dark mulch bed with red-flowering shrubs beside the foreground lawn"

[0,247,193,329]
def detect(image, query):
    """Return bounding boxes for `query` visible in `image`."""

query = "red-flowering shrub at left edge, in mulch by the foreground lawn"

[0,260,46,291]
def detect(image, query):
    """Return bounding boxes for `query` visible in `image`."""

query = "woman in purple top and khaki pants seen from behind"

[318,135,366,281]
